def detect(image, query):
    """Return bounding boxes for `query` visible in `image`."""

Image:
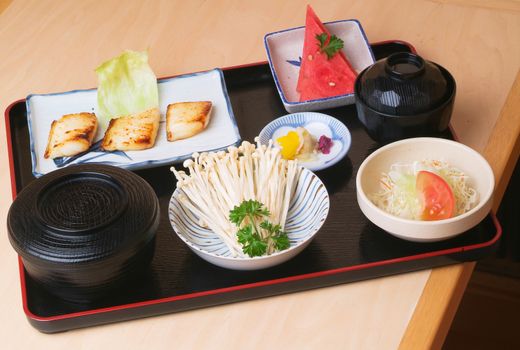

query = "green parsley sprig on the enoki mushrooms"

[229,199,290,257]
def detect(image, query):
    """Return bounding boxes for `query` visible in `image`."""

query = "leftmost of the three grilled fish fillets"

[44,113,98,159]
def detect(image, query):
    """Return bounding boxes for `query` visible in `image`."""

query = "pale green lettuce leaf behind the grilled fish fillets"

[96,50,159,127]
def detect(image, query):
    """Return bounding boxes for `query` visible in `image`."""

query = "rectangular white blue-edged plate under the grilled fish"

[26,69,241,177]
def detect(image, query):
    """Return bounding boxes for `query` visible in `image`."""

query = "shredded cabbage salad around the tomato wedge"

[370,160,478,220]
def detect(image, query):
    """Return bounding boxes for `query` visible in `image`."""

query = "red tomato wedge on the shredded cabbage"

[415,170,455,221]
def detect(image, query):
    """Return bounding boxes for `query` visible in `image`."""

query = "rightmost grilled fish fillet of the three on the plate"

[166,101,212,141]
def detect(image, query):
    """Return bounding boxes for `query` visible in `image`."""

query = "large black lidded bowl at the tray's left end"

[7,164,159,303]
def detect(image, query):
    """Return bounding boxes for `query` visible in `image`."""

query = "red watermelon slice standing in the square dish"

[296,5,357,102]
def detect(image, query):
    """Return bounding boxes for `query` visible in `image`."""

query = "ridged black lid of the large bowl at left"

[7,164,159,264]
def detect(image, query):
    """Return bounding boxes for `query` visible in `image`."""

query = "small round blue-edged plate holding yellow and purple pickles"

[259,112,352,171]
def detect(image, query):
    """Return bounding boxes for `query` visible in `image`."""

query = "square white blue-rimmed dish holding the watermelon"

[264,19,375,113]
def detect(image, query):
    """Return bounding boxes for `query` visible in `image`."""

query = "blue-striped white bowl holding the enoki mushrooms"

[168,168,330,270]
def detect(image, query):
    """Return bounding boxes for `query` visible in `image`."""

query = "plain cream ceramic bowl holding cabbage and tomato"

[356,137,495,242]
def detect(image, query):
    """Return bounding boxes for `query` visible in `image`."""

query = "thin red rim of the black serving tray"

[5,40,502,322]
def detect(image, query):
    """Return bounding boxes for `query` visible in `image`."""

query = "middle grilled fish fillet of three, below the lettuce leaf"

[101,108,161,151]
